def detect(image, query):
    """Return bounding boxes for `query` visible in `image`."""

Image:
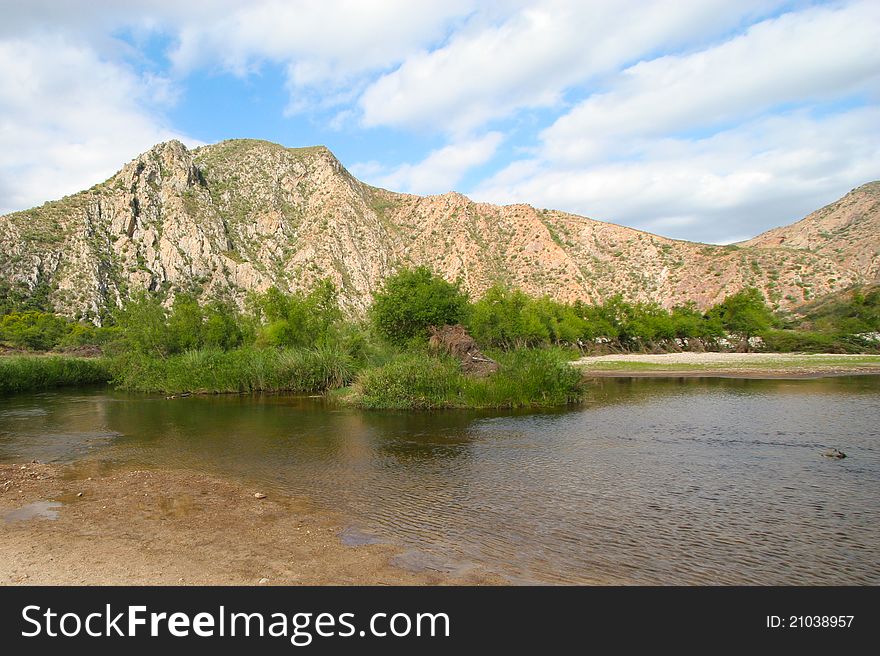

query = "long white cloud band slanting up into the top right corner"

[542,2,880,162]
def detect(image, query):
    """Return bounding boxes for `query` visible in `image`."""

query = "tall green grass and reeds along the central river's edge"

[114,347,582,409]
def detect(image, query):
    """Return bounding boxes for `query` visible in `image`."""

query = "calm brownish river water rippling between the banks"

[0,376,880,585]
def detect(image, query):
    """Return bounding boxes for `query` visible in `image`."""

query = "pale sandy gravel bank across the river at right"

[572,352,880,378]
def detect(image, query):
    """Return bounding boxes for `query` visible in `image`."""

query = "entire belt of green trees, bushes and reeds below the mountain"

[0,267,880,408]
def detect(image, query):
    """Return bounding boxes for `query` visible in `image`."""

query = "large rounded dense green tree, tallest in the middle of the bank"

[370,267,468,340]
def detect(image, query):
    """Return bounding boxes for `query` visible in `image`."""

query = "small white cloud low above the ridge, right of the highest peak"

[351,132,503,194]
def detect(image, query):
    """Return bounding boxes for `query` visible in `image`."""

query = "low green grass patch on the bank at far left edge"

[0,355,111,394]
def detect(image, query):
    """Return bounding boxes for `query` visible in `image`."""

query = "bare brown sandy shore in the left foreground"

[0,463,504,585]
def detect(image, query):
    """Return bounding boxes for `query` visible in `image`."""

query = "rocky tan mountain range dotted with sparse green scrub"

[0,140,880,318]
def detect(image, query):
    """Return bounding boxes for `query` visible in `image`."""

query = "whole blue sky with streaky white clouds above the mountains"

[0,0,880,243]
